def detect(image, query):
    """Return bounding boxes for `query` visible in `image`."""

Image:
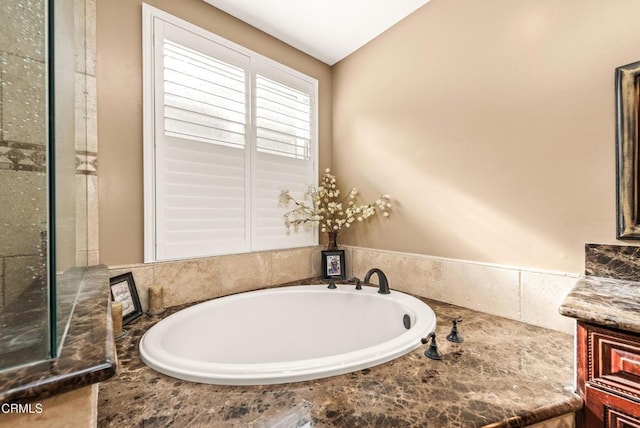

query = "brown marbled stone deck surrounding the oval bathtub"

[98,285,582,428]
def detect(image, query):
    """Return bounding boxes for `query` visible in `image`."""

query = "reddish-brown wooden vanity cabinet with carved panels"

[576,321,640,428]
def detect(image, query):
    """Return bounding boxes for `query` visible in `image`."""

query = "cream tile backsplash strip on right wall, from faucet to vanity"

[345,247,579,334]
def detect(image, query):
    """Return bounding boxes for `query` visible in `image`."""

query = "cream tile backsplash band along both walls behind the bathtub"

[110,247,578,334]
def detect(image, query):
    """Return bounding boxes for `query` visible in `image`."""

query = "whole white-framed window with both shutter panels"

[143,5,317,261]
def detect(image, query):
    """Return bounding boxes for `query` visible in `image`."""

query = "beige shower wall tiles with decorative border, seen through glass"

[0,0,47,309]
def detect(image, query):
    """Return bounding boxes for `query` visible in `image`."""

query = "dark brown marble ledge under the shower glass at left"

[0,266,117,404]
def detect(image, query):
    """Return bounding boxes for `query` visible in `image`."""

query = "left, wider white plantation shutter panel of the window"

[155,21,250,260]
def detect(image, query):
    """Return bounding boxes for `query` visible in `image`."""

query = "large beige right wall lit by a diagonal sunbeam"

[332,0,640,272]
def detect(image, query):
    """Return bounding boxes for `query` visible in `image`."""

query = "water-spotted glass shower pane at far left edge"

[0,0,50,369]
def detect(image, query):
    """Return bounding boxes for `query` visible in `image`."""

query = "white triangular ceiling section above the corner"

[204,0,429,65]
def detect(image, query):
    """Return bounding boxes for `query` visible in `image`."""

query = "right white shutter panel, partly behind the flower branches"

[253,64,317,250]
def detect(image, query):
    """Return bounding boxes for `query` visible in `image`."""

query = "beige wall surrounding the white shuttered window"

[97,0,332,265]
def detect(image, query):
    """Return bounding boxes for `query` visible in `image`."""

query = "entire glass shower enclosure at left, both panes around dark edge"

[0,0,91,371]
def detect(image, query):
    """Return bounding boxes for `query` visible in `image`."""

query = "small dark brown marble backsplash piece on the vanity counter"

[584,244,640,281]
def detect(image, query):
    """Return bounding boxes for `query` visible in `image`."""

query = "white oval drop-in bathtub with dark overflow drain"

[140,285,436,385]
